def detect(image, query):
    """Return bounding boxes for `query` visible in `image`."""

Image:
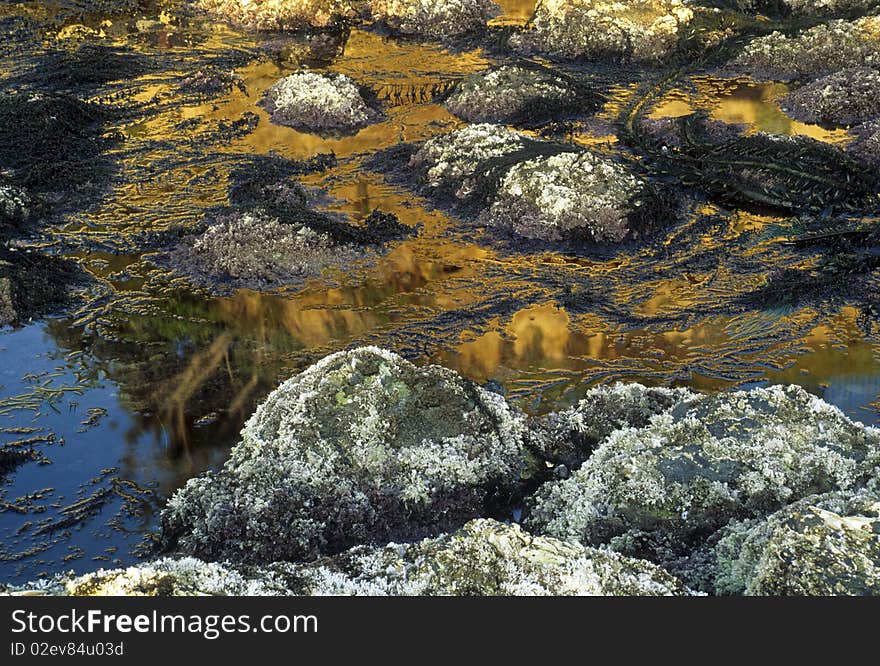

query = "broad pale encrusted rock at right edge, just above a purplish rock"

[731,16,880,80]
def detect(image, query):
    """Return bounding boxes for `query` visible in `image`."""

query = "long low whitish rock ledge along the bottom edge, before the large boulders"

[6,519,690,596]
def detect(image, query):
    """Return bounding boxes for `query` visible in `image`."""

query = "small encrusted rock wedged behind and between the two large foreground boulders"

[529,383,694,473]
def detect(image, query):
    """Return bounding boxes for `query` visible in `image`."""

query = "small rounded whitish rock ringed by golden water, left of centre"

[263,72,380,132]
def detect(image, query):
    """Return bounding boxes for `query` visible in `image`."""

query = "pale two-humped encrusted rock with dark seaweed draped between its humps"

[409,124,672,242]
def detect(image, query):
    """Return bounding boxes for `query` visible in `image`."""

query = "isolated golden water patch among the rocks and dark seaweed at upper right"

[650,76,849,143]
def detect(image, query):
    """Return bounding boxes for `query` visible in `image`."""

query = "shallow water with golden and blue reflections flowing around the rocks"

[0,0,880,580]
